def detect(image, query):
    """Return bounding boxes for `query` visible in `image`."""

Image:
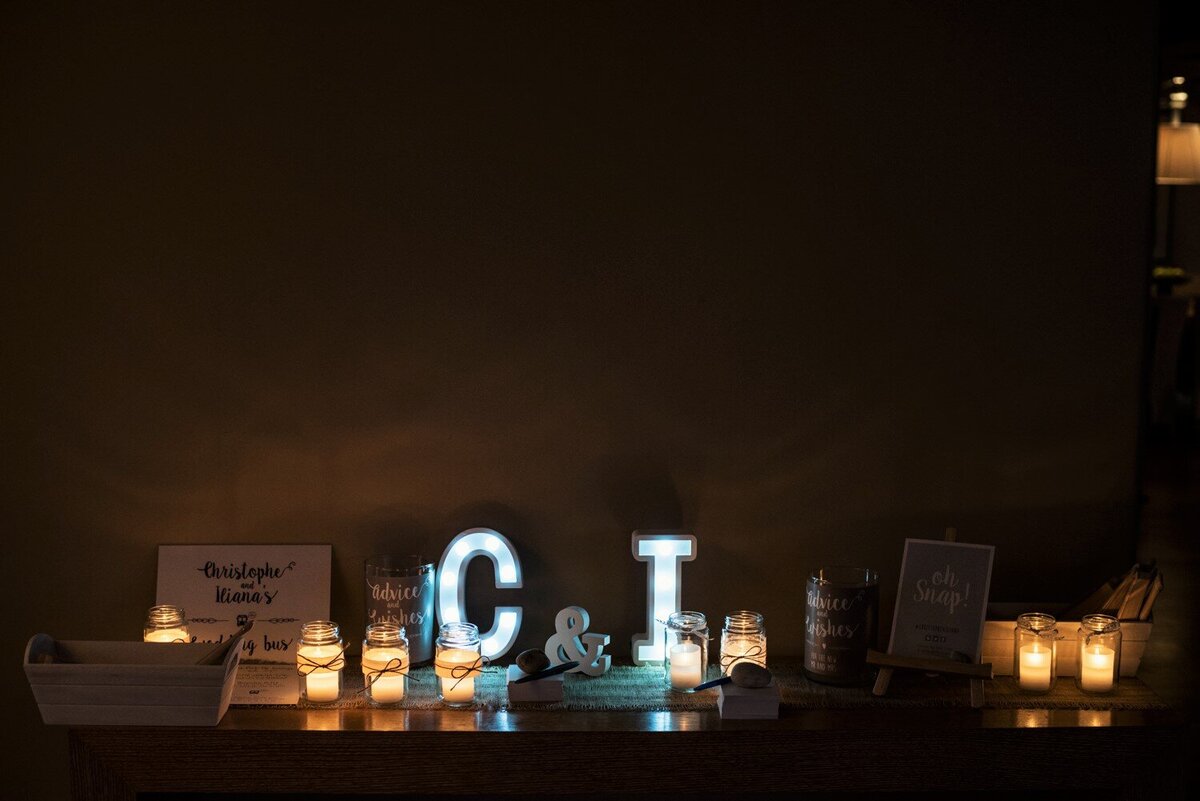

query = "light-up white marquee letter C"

[438,529,521,660]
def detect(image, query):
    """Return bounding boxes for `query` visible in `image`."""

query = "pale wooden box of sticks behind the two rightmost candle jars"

[979,603,1153,676]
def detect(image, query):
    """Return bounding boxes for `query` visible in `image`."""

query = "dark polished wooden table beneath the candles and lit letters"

[70,707,1183,801]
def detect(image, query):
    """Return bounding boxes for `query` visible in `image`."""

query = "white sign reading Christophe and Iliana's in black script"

[157,544,332,704]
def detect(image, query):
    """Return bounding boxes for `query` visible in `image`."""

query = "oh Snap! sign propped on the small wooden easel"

[888,540,995,662]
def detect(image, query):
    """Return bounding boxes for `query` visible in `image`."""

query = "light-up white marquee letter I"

[632,531,696,664]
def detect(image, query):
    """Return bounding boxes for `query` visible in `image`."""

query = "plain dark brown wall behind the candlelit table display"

[0,1,1156,795]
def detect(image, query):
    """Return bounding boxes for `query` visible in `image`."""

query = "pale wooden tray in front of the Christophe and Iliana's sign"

[25,634,241,725]
